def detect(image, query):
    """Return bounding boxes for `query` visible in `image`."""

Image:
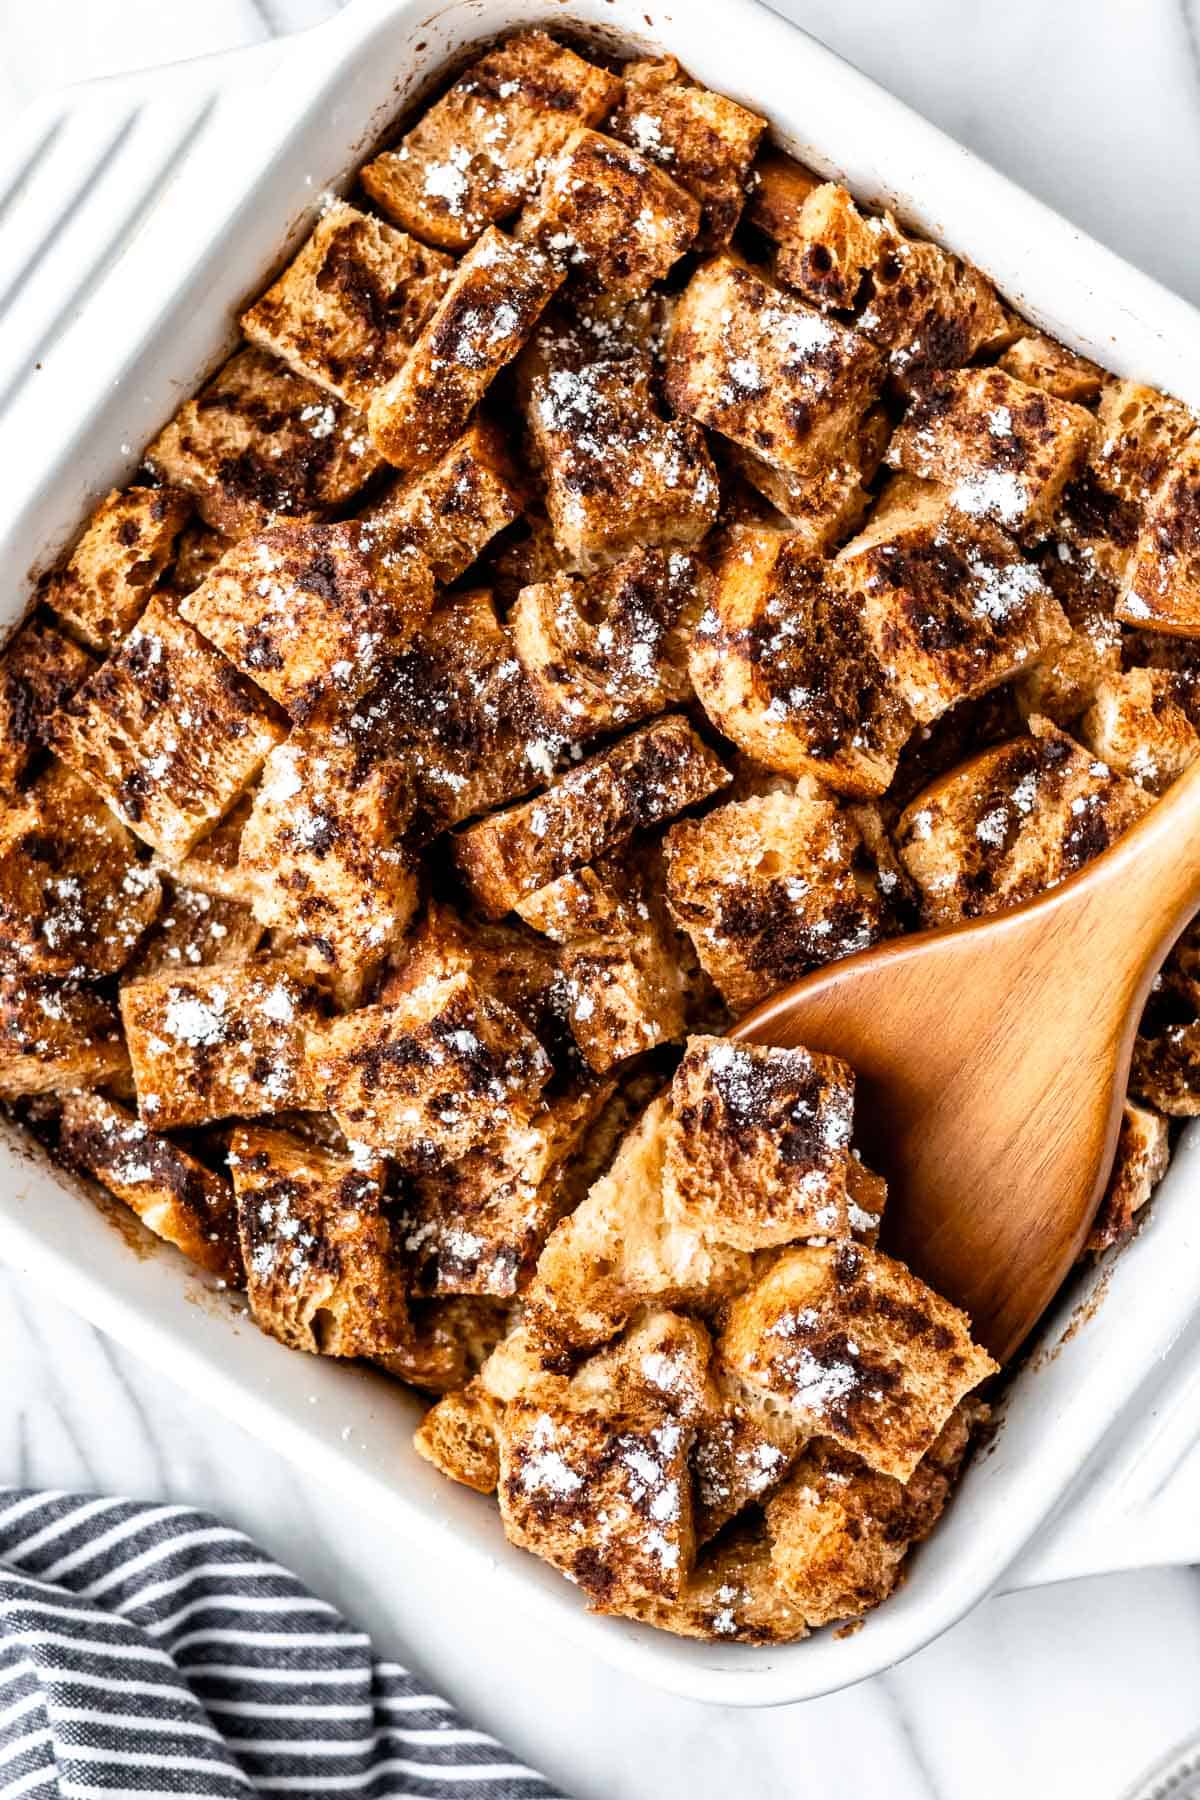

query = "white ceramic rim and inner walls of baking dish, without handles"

[0,0,1200,1705]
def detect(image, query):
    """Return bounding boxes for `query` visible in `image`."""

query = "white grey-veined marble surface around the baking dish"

[0,0,1200,1800]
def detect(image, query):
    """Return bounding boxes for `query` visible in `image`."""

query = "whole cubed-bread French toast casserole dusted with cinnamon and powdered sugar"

[9,31,1200,1643]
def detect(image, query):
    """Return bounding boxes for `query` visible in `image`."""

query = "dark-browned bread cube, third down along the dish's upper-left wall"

[146,349,380,538]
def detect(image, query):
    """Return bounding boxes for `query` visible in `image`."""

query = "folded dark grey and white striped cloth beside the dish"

[0,1487,554,1800]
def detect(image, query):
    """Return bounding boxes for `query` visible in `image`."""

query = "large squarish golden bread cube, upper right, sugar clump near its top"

[666,256,882,473]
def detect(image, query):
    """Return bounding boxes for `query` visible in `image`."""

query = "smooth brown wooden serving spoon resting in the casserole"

[732,761,1200,1361]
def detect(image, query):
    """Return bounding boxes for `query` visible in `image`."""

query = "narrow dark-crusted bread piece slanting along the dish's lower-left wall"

[58,1093,243,1287]
